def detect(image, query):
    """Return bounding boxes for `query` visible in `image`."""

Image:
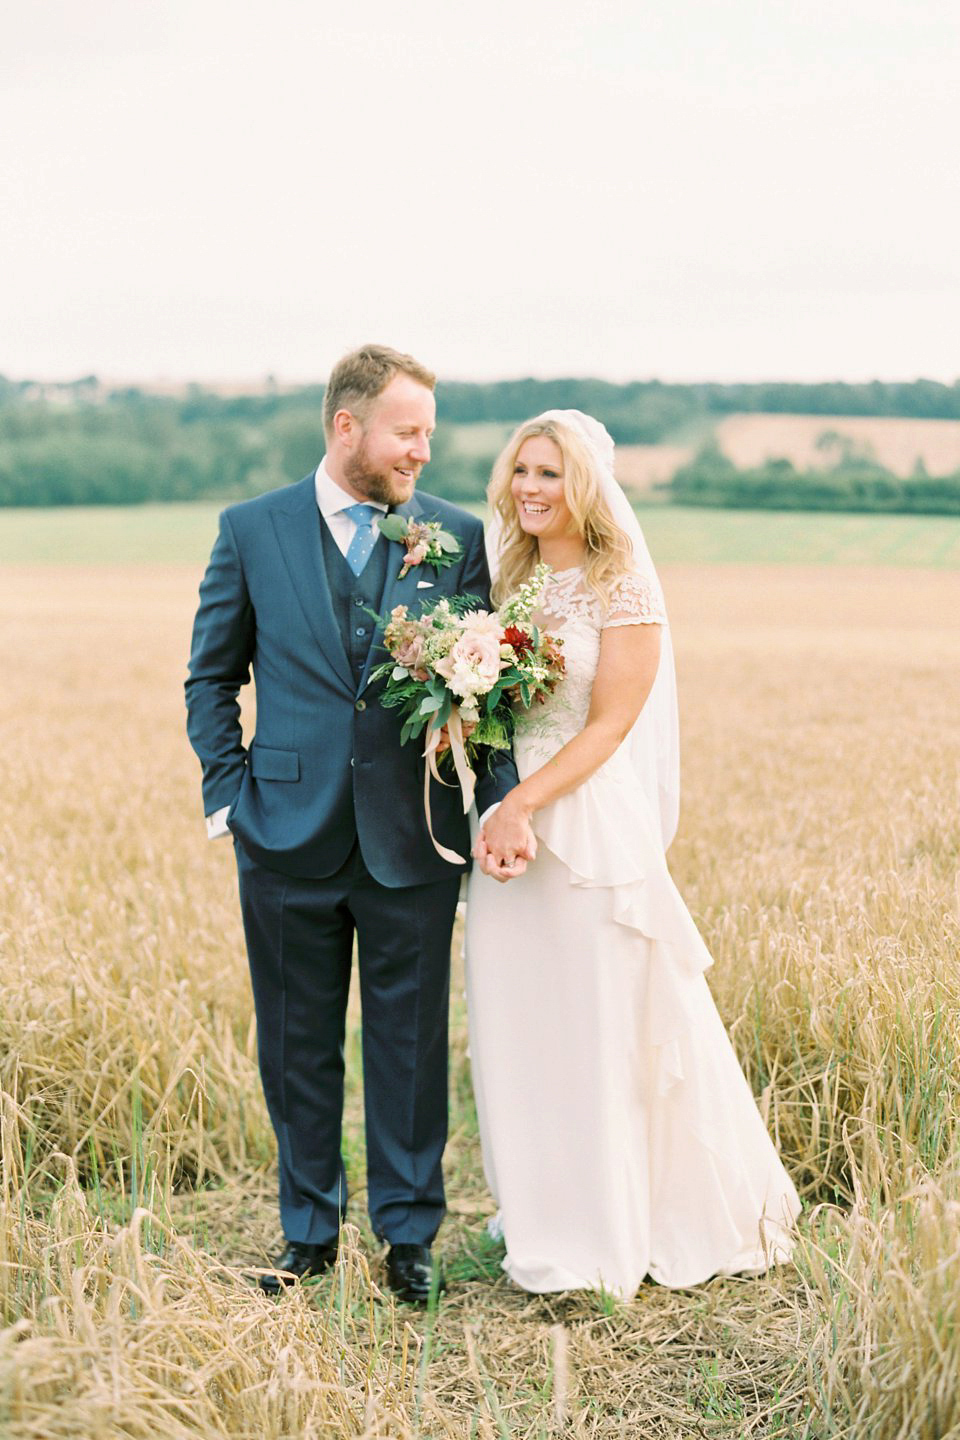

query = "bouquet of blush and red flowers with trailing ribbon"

[371,564,564,864]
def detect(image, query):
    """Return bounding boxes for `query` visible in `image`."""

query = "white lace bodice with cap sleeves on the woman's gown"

[515,566,666,779]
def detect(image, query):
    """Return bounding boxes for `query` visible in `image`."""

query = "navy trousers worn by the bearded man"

[235,842,461,1244]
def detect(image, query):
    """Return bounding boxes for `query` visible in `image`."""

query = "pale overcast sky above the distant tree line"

[0,0,960,382]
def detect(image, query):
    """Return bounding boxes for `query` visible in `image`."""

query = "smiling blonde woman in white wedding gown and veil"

[466,410,800,1296]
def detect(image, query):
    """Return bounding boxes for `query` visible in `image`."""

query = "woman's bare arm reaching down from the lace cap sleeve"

[484,624,661,854]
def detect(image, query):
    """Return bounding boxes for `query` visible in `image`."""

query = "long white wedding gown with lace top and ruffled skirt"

[466,569,800,1296]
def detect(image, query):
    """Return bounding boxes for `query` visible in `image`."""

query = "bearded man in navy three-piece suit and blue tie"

[186,346,522,1302]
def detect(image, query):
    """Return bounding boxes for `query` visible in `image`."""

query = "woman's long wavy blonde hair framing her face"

[486,419,633,606]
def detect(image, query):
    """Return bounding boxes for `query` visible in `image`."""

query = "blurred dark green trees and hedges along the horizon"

[0,376,960,513]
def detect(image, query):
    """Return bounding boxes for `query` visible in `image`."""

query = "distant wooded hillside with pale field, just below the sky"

[0,376,960,505]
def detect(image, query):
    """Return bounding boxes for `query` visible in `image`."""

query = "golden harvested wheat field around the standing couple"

[0,544,960,1440]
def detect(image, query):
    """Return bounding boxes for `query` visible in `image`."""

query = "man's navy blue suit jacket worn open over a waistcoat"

[186,474,517,888]
